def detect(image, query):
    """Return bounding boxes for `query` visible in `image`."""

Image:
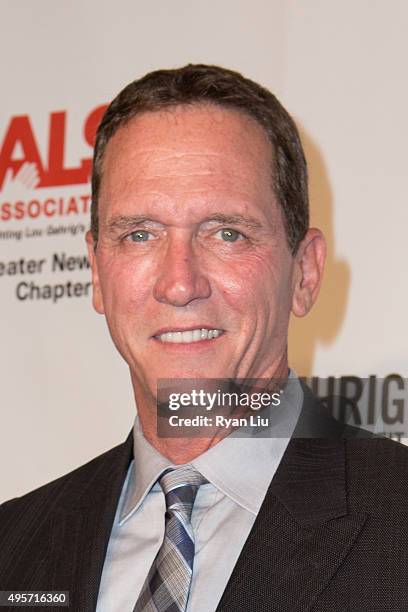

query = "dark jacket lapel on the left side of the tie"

[46,434,133,612]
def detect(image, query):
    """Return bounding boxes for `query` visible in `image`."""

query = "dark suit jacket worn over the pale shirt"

[0,392,408,612]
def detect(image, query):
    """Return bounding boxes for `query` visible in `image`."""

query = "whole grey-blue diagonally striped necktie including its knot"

[133,465,207,612]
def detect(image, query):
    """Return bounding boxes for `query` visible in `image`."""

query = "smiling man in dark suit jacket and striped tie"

[0,65,408,612]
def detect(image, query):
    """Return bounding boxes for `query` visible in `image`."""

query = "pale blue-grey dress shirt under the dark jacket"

[96,371,303,612]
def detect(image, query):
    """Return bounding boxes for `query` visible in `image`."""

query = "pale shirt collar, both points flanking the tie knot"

[119,370,303,524]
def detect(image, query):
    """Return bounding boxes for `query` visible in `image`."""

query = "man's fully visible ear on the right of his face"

[292,228,326,317]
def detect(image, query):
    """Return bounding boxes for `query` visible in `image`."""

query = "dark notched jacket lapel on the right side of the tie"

[217,394,366,612]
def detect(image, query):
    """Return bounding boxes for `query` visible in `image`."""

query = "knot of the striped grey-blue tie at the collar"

[159,465,208,520]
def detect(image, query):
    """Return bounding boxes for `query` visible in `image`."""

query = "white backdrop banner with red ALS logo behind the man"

[0,0,408,501]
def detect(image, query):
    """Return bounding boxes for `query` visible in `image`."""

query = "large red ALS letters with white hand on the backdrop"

[0,105,107,191]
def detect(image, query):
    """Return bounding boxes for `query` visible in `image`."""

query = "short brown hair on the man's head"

[91,64,309,253]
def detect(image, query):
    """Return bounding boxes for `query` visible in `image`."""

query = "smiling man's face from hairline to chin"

[88,105,302,397]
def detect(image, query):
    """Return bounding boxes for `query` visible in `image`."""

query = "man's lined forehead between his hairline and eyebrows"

[100,104,278,221]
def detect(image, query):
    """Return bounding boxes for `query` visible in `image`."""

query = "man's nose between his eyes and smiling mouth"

[153,239,211,306]
